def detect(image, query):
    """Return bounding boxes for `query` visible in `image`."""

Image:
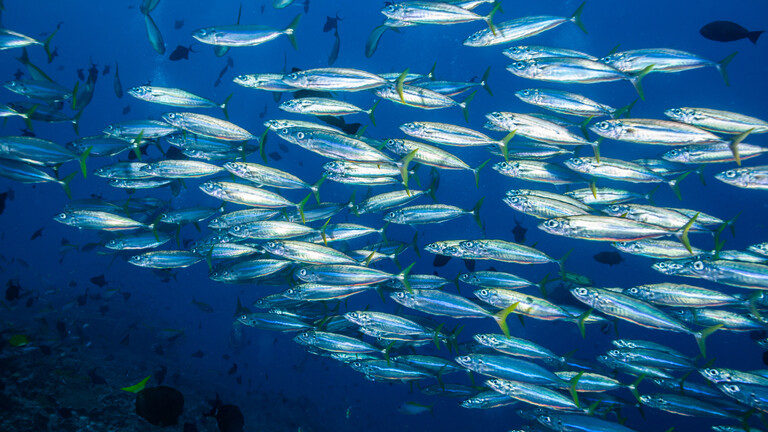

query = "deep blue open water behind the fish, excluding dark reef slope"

[0,0,768,431]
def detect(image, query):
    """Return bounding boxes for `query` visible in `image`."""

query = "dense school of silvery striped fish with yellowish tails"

[0,0,768,432]
